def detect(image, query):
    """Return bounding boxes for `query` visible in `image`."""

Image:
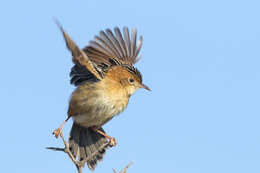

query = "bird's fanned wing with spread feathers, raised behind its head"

[83,27,143,69]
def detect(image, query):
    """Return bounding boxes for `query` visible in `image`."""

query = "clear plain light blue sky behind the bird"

[0,0,260,173]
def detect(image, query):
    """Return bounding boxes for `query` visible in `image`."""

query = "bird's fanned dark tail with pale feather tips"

[69,122,108,170]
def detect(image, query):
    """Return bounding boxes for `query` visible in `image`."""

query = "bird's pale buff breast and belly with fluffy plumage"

[70,81,129,127]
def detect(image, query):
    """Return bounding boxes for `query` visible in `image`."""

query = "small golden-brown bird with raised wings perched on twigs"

[53,23,150,170]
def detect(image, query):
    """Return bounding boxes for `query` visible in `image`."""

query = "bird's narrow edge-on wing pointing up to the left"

[57,22,103,85]
